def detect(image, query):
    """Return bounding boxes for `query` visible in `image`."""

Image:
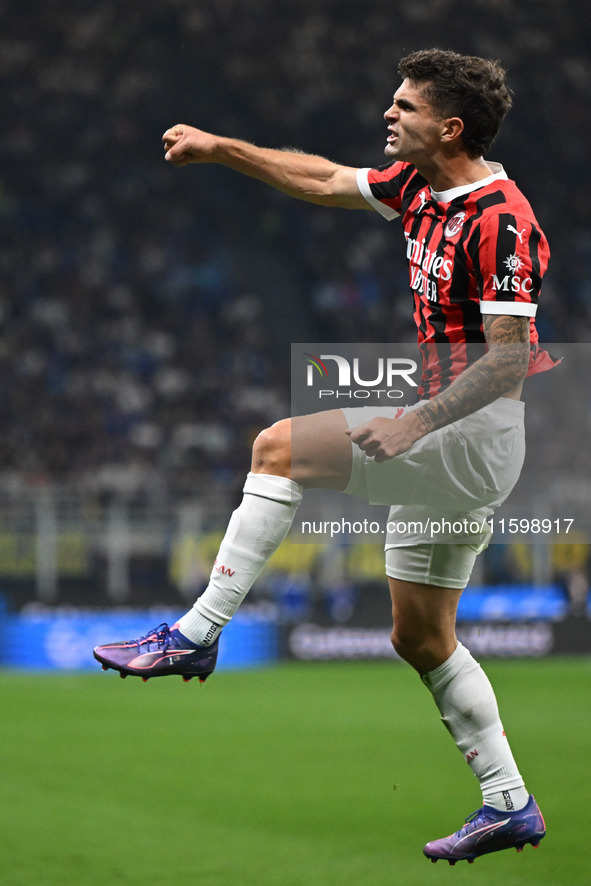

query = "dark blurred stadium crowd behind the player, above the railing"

[0,0,591,503]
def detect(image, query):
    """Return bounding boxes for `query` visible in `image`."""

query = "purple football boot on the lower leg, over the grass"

[423,796,546,864]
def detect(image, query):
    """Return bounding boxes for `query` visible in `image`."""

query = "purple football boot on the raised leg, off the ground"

[93,624,219,683]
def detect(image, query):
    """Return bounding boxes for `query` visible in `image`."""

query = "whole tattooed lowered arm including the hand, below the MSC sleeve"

[347,314,529,462]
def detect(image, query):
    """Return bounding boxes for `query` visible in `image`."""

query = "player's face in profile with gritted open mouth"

[384,80,443,165]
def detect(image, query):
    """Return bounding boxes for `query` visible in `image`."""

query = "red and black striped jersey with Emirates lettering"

[357,162,555,397]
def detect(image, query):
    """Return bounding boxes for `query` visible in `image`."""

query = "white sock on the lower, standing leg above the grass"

[422,643,529,811]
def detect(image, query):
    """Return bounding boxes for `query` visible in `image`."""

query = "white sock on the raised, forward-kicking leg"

[178,473,303,646]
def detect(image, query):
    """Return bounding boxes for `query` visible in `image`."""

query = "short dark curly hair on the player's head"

[398,49,512,157]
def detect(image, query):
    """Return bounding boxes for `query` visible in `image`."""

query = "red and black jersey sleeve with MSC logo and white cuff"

[469,213,549,317]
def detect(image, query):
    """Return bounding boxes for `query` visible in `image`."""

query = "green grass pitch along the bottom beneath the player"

[0,659,591,886]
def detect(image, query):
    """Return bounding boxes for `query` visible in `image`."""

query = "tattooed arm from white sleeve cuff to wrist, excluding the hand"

[416,314,529,432]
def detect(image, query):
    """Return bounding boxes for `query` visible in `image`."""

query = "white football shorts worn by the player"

[343,397,525,587]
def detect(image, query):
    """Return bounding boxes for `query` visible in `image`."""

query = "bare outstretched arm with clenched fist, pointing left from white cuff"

[162,124,371,209]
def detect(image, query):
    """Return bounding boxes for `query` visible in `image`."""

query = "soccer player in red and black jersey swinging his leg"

[95,50,553,864]
